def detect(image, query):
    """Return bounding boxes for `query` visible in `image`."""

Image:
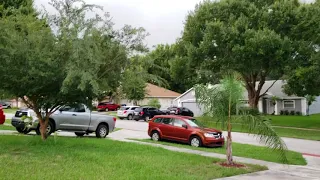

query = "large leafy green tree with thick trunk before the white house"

[182,0,319,108]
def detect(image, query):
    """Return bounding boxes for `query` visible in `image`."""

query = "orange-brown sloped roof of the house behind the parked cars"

[146,83,180,98]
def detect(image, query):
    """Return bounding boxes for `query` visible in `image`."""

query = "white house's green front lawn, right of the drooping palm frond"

[268,114,320,130]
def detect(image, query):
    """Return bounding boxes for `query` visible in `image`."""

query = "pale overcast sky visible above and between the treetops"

[35,0,312,47]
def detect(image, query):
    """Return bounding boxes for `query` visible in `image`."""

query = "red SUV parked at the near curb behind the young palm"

[148,115,224,147]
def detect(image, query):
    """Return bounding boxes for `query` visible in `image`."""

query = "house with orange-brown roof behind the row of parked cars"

[120,83,181,109]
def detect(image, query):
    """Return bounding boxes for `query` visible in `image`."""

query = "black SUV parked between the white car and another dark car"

[133,106,166,121]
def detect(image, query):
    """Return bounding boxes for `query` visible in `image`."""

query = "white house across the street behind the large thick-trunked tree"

[173,80,320,116]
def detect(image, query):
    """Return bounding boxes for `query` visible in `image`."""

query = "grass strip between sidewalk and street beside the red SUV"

[134,139,307,165]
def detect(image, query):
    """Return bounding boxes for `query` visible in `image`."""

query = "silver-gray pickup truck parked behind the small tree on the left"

[11,104,116,138]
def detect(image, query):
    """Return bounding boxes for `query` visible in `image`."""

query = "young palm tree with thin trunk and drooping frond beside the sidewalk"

[195,73,287,165]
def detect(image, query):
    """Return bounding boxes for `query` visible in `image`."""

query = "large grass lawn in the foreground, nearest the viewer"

[0,136,266,180]
